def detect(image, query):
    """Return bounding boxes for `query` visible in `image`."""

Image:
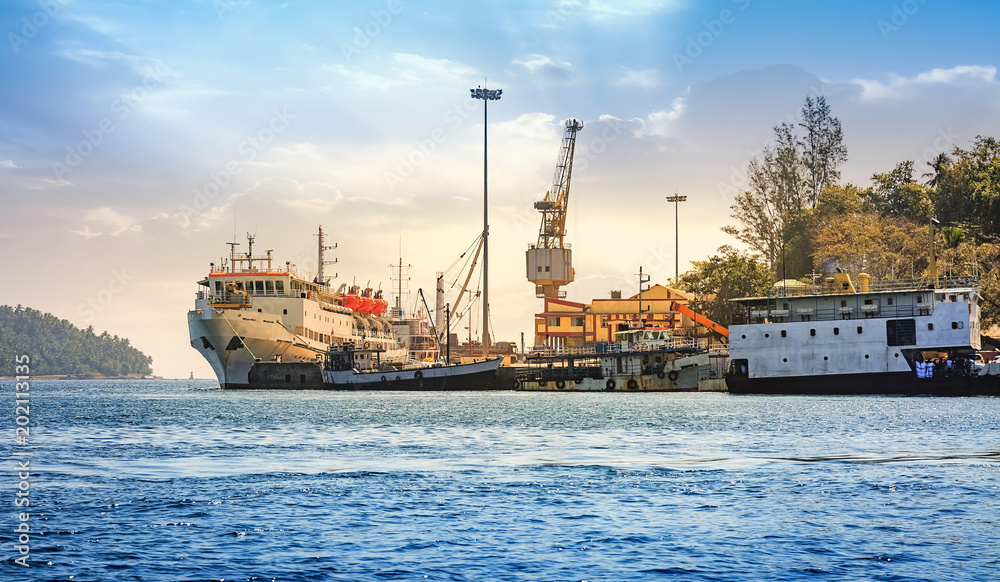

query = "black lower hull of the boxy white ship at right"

[726,372,1000,396]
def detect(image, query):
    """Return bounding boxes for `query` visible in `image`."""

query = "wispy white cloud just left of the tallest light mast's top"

[322,53,478,91]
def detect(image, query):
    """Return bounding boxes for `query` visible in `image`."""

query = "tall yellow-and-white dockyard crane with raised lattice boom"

[526,119,583,299]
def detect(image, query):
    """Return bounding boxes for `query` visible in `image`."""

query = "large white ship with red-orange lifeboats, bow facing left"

[188,227,408,388]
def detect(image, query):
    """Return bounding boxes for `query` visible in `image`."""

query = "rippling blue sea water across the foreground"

[0,380,1000,582]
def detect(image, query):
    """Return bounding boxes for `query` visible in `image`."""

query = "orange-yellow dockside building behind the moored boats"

[535,285,710,347]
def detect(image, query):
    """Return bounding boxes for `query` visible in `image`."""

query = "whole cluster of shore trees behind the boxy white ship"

[677,96,1000,329]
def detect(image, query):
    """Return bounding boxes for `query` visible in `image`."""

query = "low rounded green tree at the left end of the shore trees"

[678,246,774,325]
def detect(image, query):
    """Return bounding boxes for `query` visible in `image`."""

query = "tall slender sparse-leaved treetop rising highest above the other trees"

[798,95,847,208]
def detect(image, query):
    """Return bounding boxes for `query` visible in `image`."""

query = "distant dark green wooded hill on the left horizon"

[0,305,153,376]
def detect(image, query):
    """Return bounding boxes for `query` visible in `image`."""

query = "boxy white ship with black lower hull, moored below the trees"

[726,272,1000,396]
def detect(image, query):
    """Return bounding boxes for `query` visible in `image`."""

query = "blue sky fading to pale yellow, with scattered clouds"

[0,0,1000,378]
